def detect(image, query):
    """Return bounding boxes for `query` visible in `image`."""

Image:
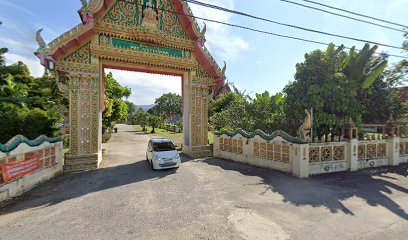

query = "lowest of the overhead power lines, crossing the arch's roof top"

[115,0,408,59]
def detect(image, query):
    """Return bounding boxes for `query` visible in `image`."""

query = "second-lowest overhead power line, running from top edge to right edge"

[183,0,405,50]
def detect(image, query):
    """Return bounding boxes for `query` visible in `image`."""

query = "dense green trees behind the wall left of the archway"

[0,62,63,143]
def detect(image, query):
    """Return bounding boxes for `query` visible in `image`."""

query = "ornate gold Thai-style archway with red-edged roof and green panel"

[35,0,225,171]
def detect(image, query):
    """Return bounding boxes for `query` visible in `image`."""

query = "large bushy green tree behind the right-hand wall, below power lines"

[285,44,387,137]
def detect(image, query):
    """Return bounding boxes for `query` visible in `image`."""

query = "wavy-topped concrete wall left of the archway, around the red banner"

[0,141,64,202]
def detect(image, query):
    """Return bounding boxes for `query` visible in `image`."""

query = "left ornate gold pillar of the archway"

[58,68,102,172]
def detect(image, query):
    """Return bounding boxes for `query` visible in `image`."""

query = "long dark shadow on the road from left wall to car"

[0,160,177,216]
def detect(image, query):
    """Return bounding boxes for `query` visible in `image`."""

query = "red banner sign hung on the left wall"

[1,155,42,183]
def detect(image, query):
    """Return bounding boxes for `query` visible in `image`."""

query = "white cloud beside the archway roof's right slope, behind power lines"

[190,0,249,60]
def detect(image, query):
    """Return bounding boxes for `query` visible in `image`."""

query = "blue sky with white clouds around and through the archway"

[0,0,408,104]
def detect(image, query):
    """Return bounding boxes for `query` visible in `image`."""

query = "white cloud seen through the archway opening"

[105,69,181,105]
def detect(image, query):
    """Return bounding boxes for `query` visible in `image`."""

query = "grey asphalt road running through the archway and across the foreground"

[0,125,408,240]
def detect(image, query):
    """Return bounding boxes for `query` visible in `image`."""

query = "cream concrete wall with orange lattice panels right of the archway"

[214,130,408,178]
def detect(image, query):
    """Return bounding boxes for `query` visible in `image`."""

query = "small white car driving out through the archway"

[146,139,181,170]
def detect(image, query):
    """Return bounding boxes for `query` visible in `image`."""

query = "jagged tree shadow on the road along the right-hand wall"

[203,158,408,219]
